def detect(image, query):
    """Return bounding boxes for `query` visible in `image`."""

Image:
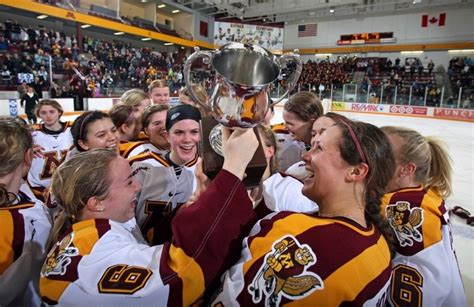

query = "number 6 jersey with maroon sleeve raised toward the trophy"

[40,171,254,307]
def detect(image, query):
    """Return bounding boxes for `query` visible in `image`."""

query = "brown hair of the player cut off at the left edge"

[0,116,33,206]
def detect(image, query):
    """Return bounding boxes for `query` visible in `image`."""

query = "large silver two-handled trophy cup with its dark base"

[184,43,303,186]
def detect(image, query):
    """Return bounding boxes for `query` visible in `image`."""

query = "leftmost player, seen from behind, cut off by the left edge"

[0,117,51,306]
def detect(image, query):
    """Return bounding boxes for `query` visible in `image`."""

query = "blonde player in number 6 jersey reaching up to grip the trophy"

[40,126,258,306]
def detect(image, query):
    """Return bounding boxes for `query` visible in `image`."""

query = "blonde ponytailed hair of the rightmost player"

[382,126,452,198]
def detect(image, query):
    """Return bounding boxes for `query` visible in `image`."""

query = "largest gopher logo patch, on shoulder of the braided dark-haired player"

[247,236,324,306]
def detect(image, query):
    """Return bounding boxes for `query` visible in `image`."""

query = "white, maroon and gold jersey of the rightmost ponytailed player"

[382,187,466,306]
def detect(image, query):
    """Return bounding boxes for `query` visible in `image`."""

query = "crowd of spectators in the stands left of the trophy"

[0,20,189,102]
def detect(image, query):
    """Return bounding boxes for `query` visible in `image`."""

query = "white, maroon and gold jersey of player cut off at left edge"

[0,184,51,306]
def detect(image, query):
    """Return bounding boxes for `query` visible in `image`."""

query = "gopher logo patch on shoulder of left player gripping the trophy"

[41,233,79,277]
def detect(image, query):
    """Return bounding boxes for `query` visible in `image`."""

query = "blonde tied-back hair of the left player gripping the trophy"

[51,148,118,244]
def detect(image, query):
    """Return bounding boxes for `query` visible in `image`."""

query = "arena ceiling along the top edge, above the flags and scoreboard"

[167,0,474,24]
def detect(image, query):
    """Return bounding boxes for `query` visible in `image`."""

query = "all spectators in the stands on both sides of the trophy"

[0,20,474,106]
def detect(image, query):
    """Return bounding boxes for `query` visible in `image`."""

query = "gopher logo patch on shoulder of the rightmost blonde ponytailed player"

[386,201,423,246]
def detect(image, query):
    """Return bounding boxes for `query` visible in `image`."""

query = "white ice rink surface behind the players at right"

[272,106,474,306]
